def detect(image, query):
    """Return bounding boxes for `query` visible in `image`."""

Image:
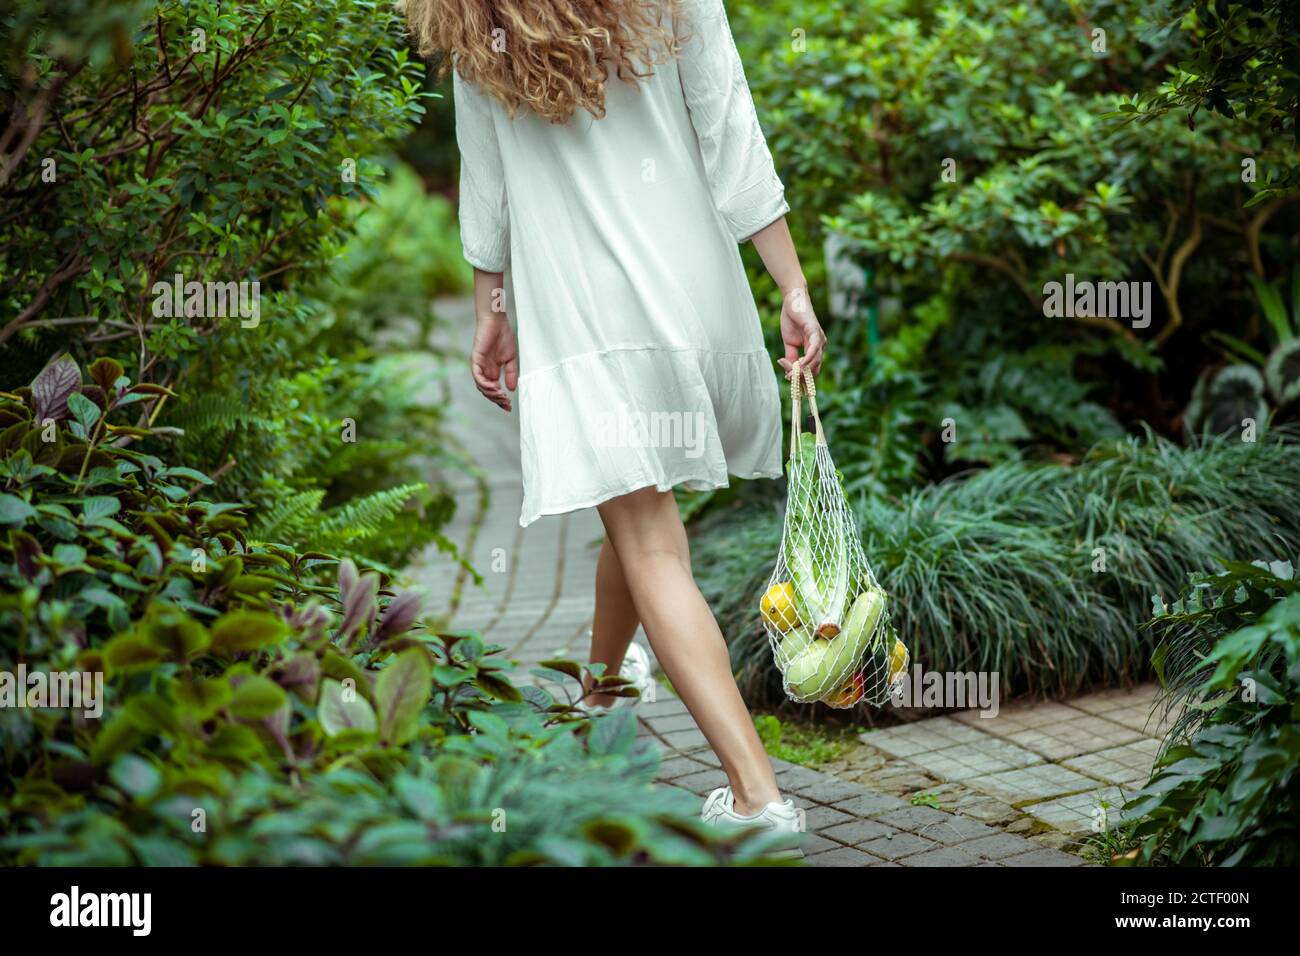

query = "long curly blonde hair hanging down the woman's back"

[397,0,680,124]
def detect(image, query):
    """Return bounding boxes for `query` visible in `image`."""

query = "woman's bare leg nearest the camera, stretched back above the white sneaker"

[599,488,780,814]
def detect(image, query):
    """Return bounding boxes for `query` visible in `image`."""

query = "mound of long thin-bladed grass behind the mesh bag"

[693,429,1300,702]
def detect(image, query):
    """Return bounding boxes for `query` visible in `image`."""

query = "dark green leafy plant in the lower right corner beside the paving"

[1122,561,1300,866]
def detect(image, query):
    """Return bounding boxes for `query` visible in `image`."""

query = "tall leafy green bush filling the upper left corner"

[0,0,465,567]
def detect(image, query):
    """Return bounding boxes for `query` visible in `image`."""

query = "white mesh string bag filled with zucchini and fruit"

[759,362,907,709]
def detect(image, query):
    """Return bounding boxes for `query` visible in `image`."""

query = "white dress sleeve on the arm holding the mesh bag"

[677,0,790,242]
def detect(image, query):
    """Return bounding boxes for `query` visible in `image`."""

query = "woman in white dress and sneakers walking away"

[404,0,826,830]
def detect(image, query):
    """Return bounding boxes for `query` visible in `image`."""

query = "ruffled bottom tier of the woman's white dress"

[519,347,783,527]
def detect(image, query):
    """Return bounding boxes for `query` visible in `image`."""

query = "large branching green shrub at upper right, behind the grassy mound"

[733,0,1300,478]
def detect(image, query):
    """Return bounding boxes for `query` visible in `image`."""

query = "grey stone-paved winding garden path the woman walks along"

[411,299,1102,866]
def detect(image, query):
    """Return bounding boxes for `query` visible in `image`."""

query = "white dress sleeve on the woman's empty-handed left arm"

[452,70,510,272]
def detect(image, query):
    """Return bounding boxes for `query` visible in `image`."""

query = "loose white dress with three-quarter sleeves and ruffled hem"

[454,0,789,525]
